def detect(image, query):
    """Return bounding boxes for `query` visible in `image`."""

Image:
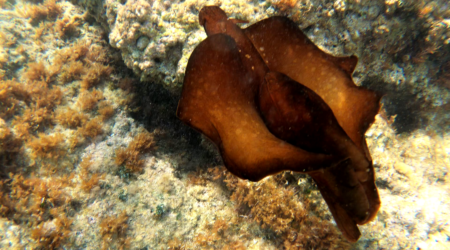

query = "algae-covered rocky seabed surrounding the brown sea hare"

[0,0,450,249]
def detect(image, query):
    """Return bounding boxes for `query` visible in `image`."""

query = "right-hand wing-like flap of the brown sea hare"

[244,17,381,227]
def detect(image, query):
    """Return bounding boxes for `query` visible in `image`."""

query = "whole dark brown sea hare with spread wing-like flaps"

[177,6,381,242]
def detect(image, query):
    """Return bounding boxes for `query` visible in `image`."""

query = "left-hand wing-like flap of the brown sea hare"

[177,34,344,181]
